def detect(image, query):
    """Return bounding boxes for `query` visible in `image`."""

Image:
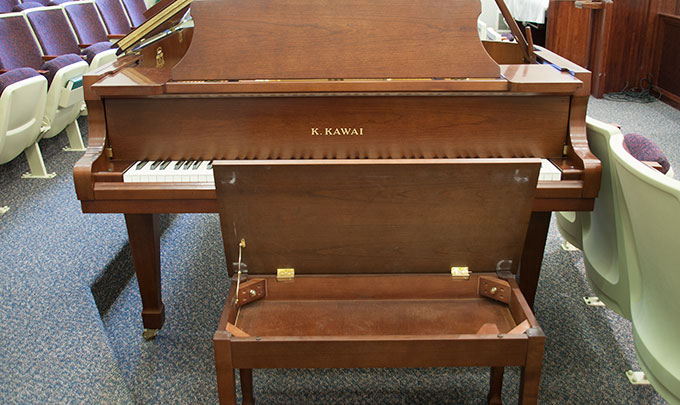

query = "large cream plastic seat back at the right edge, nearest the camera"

[610,135,680,403]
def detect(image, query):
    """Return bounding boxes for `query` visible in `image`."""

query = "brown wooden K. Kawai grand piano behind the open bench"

[73,0,600,336]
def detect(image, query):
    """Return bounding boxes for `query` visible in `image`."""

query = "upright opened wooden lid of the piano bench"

[213,159,540,275]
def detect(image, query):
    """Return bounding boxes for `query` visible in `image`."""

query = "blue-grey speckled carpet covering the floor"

[0,96,680,404]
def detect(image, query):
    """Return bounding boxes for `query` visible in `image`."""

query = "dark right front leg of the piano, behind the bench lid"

[518,211,552,308]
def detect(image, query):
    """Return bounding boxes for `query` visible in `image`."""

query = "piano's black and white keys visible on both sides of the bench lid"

[123,159,562,183]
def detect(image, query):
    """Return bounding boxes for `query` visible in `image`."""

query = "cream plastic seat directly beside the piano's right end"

[556,117,632,319]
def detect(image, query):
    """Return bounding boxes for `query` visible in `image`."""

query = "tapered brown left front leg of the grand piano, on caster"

[125,214,165,330]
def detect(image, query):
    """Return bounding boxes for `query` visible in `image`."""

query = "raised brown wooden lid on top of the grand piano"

[172,0,500,81]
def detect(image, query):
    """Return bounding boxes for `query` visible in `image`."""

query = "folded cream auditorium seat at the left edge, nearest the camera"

[0,68,54,178]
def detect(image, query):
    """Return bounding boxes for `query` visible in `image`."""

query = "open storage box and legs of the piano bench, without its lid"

[213,275,545,404]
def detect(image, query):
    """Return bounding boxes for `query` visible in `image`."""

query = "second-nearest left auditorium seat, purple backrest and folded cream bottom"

[0,13,88,150]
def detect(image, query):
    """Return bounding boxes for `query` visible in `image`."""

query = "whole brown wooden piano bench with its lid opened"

[213,159,545,404]
